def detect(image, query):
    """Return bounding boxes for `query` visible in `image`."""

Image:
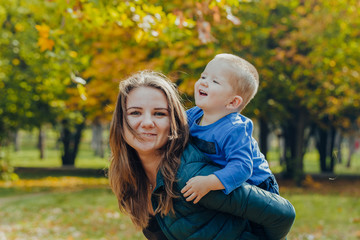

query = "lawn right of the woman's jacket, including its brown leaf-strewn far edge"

[279,179,360,240]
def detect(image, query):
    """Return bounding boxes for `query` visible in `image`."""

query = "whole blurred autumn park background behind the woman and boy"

[0,0,360,240]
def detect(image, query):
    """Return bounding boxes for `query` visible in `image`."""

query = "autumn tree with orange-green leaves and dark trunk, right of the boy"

[214,1,359,181]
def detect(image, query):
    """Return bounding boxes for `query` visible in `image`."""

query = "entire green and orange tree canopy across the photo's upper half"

[0,0,360,176]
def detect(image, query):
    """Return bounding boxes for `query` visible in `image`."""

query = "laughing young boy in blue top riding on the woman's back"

[181,54,279,203]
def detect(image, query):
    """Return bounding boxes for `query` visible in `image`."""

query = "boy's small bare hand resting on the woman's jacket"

[181,174,224,204]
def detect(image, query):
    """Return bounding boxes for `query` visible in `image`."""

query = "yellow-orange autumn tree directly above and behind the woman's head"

[28,1,240,164]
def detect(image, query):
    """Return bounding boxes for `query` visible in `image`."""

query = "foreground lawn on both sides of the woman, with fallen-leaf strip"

[0,177,360,240]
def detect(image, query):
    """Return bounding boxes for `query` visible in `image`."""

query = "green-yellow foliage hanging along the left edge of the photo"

[0,0,65,140]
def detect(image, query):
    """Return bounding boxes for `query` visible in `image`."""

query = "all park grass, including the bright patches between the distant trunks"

[0,130,360,240]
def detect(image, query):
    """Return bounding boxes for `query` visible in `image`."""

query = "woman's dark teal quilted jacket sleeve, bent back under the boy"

[180,144,295,240]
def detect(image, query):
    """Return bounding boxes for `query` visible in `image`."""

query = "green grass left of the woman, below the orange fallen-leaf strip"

[0,188,144,240]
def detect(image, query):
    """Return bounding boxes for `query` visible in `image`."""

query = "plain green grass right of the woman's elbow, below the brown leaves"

[282,192,360,240]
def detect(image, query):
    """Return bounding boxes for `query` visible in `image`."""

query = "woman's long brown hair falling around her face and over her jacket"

[109,71,188,228]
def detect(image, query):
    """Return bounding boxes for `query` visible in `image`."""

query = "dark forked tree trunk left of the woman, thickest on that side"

[61,120,85,166]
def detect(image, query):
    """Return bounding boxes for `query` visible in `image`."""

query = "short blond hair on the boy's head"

[214,53,259,111]
